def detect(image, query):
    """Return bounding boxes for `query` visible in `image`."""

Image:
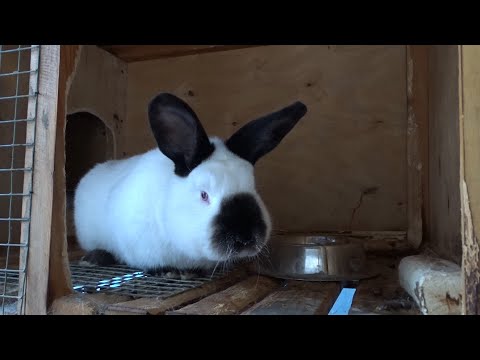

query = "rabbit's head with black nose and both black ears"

[148,93,307,261]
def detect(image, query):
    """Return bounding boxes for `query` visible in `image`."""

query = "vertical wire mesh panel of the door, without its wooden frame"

[0,45,40,315]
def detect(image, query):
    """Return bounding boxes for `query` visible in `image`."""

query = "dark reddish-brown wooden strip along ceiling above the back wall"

[99,45,258,62]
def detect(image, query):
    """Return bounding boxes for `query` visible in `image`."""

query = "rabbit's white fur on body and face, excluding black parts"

[74,137,271,269]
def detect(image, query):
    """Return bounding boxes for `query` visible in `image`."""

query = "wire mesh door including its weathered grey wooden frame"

[0,45,60,315]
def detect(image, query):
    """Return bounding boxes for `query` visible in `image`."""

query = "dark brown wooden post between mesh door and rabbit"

[48,45,82,305]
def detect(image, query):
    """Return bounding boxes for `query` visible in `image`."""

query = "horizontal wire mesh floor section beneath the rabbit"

[70,262,228,299]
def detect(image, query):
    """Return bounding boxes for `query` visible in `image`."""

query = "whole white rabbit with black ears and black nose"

[74,93,307,278]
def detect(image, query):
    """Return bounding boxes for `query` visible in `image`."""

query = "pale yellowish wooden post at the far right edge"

[460,45,480,315]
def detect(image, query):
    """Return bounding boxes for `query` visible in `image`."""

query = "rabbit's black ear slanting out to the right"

[225,101,307,165]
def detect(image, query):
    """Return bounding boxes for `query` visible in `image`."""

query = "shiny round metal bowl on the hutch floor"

[256,235,376,281]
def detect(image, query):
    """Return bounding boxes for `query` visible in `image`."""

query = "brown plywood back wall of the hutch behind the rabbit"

[125,45,407,232]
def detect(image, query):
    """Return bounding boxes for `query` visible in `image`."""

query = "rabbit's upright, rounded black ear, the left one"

[148,93,215,177]
